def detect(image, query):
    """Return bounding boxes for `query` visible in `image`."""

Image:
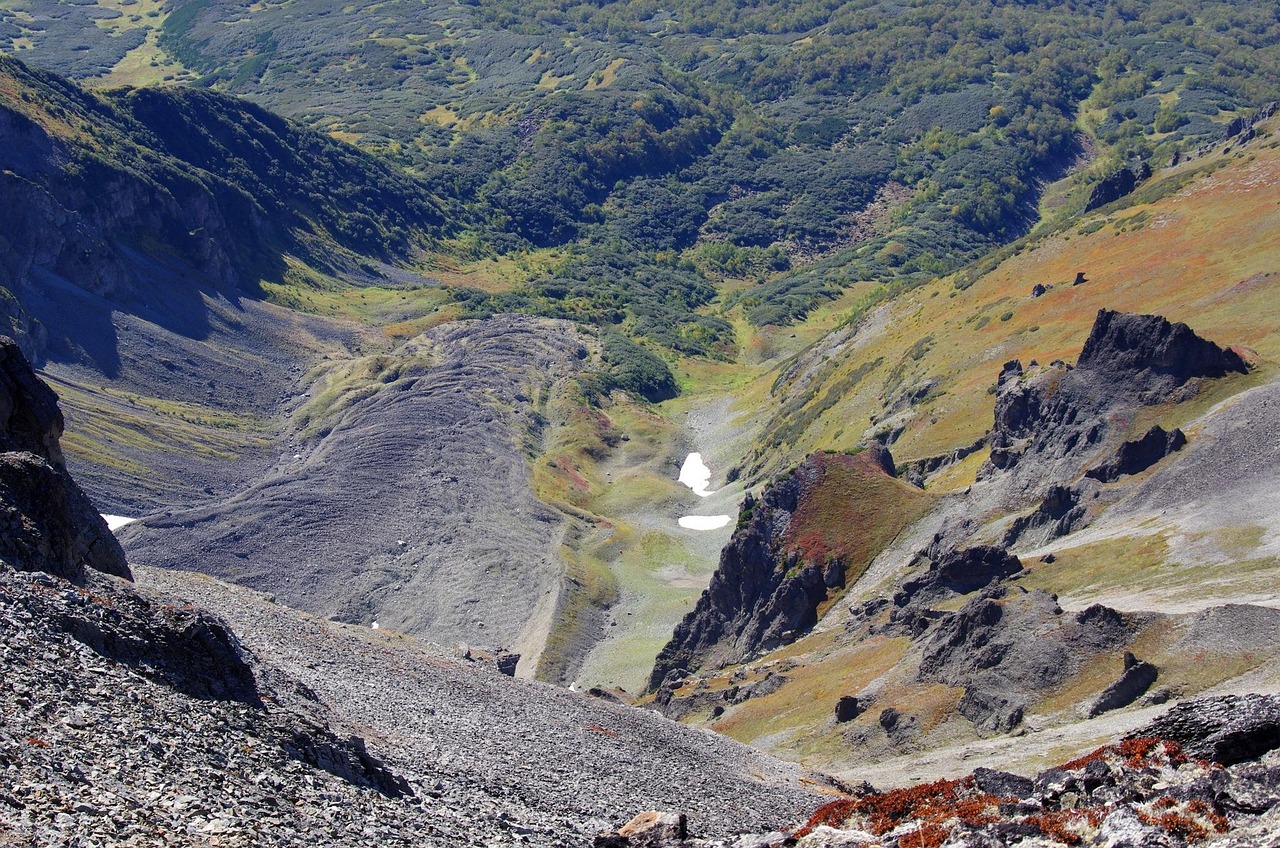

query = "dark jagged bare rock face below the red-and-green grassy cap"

[649,446,893,689]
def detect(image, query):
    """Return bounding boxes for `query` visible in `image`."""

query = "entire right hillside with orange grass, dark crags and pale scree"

[650,112,1280,780]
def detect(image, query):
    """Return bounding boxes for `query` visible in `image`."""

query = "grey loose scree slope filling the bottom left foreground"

[0,347,833,848]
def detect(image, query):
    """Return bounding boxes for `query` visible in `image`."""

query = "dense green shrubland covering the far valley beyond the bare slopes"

[0,0,1280,374]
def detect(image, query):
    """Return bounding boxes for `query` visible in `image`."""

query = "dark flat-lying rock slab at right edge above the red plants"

[1132,694,1280,765]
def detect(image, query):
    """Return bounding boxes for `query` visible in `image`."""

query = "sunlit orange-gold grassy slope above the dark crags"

[751,117,1280,488]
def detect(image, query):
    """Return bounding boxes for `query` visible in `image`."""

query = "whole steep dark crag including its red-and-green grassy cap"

[649,447,928,688]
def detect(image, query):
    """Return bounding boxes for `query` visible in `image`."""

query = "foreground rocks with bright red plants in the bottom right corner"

[595,694,1280,848]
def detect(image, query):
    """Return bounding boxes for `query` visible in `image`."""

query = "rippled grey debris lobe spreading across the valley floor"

[120,316,588,676]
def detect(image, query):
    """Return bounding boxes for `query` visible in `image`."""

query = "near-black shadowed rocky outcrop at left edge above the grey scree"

[0,337,129,583]
